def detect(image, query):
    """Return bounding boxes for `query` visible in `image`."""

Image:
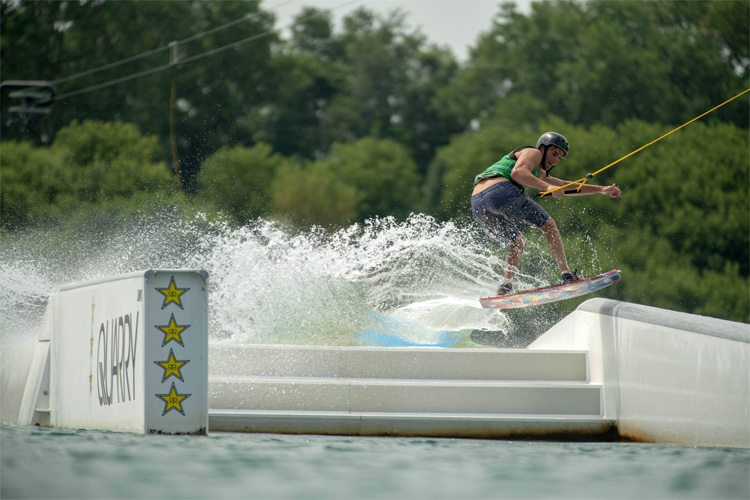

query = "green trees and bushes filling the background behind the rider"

[0,0,750,321]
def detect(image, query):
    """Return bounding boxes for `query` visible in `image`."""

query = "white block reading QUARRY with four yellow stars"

[50,270,208,434]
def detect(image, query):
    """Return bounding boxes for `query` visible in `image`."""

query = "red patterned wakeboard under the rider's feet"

[479,269,620,309]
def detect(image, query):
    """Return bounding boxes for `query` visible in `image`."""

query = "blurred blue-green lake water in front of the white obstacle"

[0,427,750,500]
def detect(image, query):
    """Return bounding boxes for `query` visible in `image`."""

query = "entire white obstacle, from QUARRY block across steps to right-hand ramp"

[0,270,750,448]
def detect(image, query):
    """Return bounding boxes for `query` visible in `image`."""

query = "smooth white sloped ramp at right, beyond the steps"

[528,298,750,448]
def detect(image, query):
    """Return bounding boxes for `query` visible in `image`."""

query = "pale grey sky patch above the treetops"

[262,0,532,61]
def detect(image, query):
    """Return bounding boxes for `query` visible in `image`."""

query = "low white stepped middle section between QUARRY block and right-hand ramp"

[208,345,615,437]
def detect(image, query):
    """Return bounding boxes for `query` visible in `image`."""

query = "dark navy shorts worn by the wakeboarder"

[471,181,549,242]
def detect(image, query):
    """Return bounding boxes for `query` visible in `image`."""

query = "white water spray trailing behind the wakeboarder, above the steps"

[0,211,564,345]
